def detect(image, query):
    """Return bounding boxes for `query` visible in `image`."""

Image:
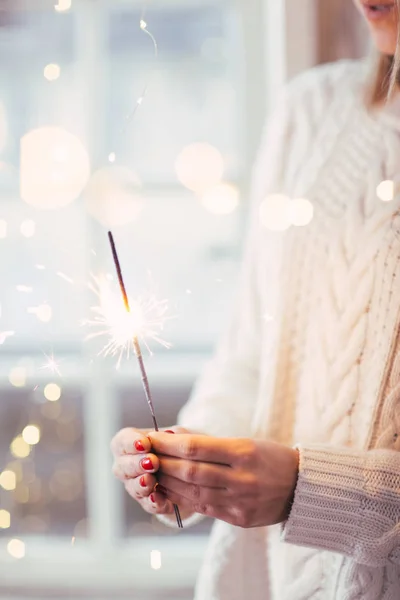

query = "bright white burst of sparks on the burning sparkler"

[83,277,171,368]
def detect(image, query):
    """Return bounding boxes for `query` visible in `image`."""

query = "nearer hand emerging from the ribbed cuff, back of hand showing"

[149,432,298,527]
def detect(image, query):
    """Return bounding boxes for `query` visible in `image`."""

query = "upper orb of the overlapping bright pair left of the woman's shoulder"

[175,143,224,194]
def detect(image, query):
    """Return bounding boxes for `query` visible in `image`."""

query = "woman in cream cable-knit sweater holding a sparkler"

[112,0,400,600]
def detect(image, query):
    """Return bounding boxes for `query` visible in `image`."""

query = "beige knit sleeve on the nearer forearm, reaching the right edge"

[282,445,400,567]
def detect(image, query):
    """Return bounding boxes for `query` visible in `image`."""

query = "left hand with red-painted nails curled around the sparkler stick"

[111,427,193,519]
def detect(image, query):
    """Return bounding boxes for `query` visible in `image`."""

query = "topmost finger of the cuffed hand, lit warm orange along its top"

[149,431,238,465]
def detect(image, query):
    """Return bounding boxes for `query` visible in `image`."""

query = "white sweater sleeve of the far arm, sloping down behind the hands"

[178,89,298,437]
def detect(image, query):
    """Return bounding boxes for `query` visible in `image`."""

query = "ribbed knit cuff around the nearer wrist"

[281,445,365,556]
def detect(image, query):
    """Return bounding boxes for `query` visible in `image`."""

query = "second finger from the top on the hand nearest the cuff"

[159,456,234,488]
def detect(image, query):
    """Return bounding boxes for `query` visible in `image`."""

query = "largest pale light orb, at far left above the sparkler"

[20,127,90,210]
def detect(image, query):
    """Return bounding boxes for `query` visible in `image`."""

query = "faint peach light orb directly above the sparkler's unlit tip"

[84,166,143,228]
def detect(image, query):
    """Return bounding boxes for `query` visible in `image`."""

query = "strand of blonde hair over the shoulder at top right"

[367,0,400,106]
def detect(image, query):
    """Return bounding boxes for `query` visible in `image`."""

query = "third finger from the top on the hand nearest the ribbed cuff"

[158,475,232,506]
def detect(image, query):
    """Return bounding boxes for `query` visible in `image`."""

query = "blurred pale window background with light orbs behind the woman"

[0,0,366,600]
